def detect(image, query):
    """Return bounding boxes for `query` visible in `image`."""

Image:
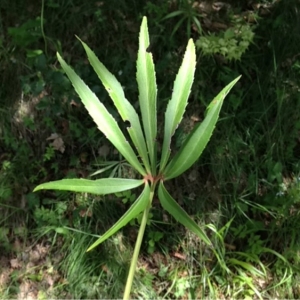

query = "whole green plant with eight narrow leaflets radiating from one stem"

[34,17,239,299]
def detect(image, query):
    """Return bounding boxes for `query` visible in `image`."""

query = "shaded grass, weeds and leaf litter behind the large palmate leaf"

[0,0,300,299]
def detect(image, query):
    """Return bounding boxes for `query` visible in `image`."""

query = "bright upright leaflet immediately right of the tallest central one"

[160,39,196,172]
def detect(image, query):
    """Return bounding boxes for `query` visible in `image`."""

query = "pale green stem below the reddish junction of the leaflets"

[123,184,155,300]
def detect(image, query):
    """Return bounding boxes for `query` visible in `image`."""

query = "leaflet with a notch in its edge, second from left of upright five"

[78,38,150,172]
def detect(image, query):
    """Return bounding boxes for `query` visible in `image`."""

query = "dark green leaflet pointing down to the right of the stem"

[158,182,211,245]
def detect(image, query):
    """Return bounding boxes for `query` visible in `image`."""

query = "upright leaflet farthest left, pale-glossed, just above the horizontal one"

[57,53,146,175]
